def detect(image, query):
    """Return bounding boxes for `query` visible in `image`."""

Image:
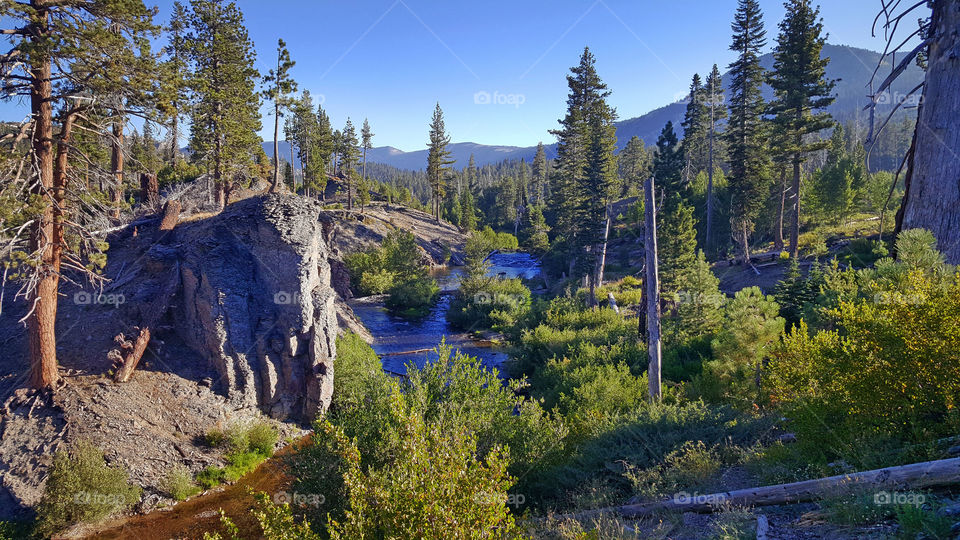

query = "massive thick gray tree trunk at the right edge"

[897,0,960,264]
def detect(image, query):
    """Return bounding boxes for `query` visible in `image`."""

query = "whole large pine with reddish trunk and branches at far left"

[0,0,156,388]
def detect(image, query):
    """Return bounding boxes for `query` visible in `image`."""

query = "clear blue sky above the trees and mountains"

[0,0,900,151]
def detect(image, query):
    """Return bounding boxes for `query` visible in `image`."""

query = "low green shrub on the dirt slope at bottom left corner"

[37,442,142,536]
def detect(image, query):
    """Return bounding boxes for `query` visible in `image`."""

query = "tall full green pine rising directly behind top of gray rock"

[187,0,260,208]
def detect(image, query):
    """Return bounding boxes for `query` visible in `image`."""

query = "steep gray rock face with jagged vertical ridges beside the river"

[173,195,337,420]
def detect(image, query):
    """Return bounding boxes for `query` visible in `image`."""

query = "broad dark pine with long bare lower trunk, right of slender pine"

[769,0,836,257]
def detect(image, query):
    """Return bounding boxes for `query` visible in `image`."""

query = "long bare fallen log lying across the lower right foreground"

[618,458,960,517]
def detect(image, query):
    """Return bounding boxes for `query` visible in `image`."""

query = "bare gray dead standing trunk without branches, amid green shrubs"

[644,176,662,401]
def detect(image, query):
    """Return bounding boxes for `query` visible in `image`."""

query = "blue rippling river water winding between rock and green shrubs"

[350,252,540,375]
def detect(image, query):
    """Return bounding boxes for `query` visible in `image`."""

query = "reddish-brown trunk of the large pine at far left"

[27,45,63,388]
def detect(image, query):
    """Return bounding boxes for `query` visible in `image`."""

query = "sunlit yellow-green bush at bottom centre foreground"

[322,394,521,539]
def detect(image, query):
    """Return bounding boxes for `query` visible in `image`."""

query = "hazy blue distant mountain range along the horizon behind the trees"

[263,44,924,170]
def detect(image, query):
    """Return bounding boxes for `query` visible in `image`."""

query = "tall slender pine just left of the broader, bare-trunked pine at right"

[725,0,768,262]
